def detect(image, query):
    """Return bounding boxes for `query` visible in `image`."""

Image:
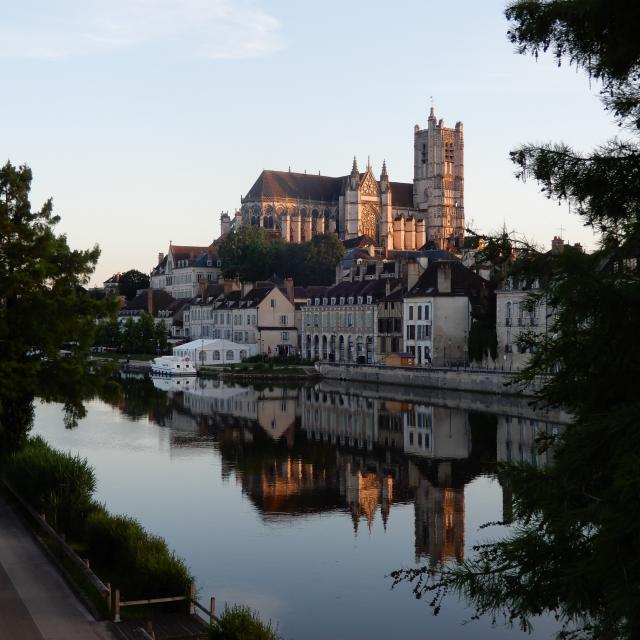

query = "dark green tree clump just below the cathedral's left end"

[219,225,344,285]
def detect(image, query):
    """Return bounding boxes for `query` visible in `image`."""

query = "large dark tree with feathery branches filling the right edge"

[394,0,640,638]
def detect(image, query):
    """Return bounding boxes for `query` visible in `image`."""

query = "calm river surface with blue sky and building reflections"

[34,379,561,640]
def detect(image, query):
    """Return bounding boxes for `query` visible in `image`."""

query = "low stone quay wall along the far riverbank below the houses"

[316,362,542,396]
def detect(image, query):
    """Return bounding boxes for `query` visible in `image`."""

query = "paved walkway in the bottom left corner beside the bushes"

[0,496,114,640]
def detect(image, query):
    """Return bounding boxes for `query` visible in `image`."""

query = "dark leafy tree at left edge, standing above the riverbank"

[0,163,113,447]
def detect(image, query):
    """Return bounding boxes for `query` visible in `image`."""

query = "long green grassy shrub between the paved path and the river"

[5,437,193,599]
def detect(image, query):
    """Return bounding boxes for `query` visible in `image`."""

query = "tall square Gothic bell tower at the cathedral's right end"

[413,107,465,249]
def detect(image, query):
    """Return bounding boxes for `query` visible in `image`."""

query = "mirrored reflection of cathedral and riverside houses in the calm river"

[139,379,558,565]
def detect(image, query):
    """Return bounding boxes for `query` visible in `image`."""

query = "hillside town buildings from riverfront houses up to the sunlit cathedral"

[104,107,581,371]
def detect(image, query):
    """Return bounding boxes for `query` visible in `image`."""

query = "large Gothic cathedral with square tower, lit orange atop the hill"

[220,107,465,251]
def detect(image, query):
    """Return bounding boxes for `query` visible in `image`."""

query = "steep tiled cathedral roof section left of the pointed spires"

[245,169,345,203]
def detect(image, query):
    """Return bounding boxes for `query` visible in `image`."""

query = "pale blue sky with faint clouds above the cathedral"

[0,0,617,282]
